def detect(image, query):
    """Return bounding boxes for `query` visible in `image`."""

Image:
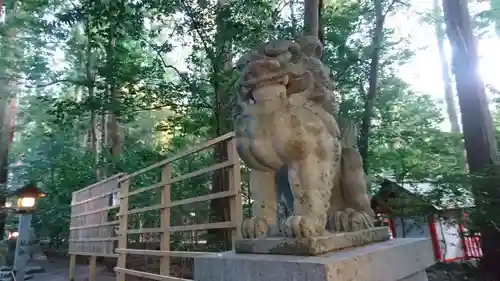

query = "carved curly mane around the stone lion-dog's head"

[231,36,337,120]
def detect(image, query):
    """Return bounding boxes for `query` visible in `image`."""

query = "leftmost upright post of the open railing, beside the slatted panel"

[116,180,130,281]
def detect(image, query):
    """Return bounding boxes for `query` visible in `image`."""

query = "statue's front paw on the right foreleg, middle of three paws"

[284,216,325,238]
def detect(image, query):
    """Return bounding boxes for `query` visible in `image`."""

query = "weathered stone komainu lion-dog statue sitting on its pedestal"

[233,36,373,238]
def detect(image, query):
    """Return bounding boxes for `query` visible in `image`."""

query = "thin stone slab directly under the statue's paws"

[234,227,390,256]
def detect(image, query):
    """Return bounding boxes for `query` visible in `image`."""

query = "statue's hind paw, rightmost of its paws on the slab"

[327,208,373,232]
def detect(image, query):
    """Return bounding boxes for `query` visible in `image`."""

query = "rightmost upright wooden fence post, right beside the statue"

[227,138,243,245]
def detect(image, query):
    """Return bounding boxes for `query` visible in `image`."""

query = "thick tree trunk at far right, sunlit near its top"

[443,0,500,280]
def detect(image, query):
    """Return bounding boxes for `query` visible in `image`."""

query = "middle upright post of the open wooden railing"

[160,164,172,275]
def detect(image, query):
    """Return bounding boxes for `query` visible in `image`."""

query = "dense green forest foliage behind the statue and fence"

[1,0,478,244]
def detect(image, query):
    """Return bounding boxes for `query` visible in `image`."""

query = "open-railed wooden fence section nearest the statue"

[115,133,243,281]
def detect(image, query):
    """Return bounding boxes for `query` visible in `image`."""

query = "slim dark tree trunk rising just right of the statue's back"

[359,0,385,174]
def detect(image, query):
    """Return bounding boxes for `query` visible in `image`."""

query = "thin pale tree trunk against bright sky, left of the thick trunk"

[433,0,460,133]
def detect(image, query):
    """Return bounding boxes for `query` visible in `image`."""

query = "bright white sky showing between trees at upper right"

[387,0,500,130]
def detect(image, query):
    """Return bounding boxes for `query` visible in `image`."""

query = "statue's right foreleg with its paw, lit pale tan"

[285,154,335,237]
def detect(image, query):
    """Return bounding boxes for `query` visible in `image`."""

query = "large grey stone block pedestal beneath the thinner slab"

[194,238,434,281]
